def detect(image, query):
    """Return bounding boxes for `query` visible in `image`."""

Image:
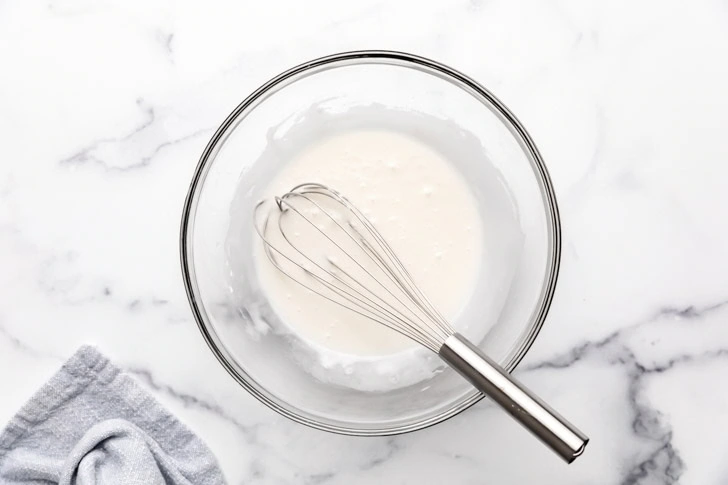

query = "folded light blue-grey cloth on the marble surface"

[0,346,224,485]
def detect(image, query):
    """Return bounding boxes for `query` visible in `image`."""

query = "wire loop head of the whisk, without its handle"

[254,183,454,352]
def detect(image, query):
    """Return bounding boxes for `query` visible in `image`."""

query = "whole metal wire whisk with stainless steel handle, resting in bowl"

[254,183,588,463]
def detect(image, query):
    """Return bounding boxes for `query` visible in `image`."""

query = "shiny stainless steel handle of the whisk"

[439,333,589,463]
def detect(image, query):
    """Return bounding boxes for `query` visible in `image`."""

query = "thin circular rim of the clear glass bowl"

[180,50,561,436]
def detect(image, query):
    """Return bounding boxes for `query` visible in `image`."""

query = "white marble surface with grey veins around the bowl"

[0,0,728,484]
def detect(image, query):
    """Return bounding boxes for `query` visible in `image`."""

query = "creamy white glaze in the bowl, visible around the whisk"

[256,130,483,356]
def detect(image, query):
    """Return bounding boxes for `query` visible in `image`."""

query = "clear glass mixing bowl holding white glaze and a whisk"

[181,51,560,435]
